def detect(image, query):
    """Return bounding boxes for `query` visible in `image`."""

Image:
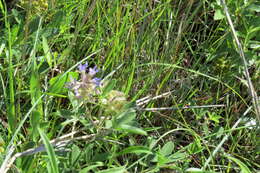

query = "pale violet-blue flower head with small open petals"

[67,62,101,101]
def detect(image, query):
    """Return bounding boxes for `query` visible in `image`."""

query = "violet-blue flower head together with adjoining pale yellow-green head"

[67,63,128,114]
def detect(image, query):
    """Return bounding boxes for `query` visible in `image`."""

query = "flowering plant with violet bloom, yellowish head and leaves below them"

[67,63,147,135]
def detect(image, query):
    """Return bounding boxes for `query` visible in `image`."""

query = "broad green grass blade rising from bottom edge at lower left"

[38,128,59,173]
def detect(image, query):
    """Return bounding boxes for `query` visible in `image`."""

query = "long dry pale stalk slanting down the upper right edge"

[221,0,260,124]
